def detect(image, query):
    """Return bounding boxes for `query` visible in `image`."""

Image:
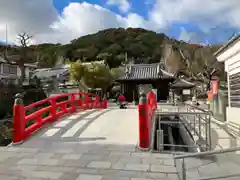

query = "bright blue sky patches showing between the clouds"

[50,0,238,43]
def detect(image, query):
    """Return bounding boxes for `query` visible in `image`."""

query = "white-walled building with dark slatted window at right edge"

[214,35,240,124]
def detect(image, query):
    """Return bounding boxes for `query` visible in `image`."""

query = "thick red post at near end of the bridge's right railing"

[138,93,150,149]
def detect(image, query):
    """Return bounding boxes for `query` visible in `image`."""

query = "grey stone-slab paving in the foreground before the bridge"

[0,143,177,180]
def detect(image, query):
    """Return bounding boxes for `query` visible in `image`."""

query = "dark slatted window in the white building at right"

[229,72,240,107]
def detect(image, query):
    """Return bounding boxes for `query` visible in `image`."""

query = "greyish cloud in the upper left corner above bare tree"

[0,0,58,42]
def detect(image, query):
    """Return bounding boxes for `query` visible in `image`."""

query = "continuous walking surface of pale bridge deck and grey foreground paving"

[0,107,178,180]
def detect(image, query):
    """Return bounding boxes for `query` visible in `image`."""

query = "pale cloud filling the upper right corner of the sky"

[149,0,240,32]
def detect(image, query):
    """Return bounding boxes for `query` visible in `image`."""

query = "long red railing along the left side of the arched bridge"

[13,92,108,144]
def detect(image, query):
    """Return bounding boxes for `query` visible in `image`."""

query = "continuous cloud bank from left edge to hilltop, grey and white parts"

[0,0,148,43]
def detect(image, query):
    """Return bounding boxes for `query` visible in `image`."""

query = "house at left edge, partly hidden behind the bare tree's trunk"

[0,57,37,84]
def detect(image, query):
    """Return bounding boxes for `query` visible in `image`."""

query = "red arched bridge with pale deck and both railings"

[13,92,156,148]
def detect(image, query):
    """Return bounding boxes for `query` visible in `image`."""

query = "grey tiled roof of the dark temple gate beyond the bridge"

[119,63,174,80]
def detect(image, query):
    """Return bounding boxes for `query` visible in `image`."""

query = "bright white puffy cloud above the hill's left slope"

[49,3,152,44]
